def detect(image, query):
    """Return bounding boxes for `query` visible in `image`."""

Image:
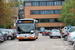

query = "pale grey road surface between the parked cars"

[0,34,72,50]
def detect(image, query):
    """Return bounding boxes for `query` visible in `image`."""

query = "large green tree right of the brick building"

[59,0,75,26]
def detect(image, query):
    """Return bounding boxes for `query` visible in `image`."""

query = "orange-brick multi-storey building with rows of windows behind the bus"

[24,0,64,29]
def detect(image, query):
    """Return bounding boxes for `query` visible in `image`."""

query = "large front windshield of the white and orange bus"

[17,23,34,33]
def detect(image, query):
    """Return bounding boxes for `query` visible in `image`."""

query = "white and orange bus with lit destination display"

[16,19,38,41]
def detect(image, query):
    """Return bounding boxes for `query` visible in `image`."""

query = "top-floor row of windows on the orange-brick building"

[31,1,64,6]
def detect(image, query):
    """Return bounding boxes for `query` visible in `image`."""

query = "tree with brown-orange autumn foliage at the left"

[0,0,13,28]
